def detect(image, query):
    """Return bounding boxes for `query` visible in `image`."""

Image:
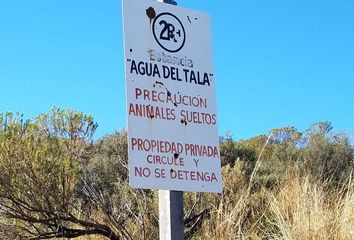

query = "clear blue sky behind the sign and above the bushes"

[0,0,354,139]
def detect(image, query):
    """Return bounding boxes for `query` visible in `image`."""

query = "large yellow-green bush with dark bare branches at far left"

[0,108,123,239]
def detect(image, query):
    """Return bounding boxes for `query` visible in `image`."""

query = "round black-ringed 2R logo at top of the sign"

[152,12,186,52]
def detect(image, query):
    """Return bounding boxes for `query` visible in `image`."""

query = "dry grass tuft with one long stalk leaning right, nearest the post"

[199,133,272,239]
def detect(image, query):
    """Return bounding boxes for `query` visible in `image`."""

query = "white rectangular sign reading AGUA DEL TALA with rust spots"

[123,0,222,192]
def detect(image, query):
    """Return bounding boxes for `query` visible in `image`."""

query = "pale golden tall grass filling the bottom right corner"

[268,174,354,240]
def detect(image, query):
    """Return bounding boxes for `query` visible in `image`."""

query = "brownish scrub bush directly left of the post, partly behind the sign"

[78,131,158,239]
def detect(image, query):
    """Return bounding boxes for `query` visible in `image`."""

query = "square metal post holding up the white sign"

[157,0,184,237]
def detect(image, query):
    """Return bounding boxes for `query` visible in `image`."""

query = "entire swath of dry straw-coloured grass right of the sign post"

[196,170,354,240]
